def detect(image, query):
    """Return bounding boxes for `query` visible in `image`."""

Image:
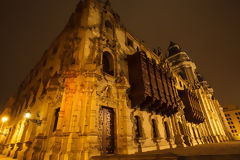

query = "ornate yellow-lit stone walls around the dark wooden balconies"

[0,0,229,160]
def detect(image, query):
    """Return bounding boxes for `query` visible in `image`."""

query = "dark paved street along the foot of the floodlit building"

[0,141,240,160]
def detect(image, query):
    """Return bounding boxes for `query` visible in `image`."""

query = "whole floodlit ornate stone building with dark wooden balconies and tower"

[0,0,232,160]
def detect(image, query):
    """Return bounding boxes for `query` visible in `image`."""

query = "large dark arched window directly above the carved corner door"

[102,52,114,76]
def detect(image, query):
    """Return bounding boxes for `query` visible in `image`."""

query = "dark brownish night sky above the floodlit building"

[0,0,240,109]
